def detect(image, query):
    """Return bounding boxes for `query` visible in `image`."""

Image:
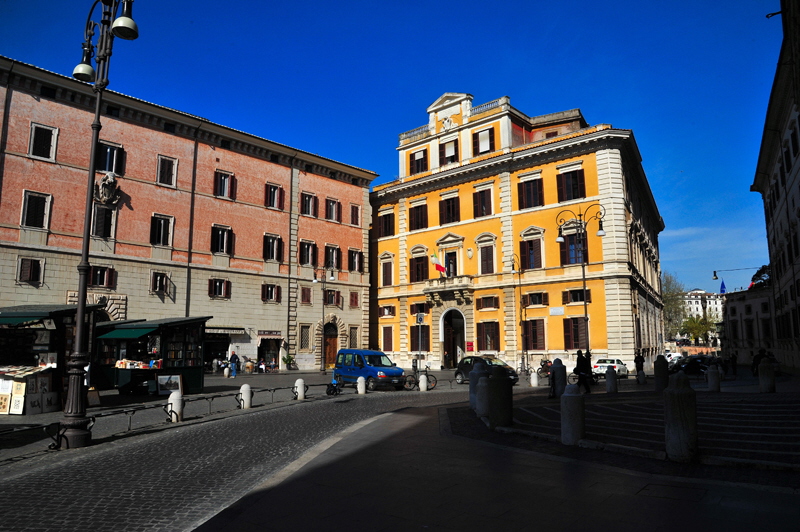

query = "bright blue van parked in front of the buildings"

[333,349,404,391]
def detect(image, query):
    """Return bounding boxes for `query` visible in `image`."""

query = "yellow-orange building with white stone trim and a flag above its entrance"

[370,93,664,368]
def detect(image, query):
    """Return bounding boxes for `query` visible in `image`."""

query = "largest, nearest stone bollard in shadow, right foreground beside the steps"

[663,371,697,462]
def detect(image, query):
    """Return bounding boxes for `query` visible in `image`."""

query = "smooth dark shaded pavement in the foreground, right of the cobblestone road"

[196,370,800,532]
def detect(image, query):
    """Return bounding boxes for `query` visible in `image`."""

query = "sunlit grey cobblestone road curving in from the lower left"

[0,387,476,532]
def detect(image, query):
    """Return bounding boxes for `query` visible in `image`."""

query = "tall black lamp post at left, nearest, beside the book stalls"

[61,0,139,448]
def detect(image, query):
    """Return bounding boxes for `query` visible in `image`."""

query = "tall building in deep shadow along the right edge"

[752,0,800,371]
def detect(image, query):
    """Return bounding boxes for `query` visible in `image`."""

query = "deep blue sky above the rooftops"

[0,0,782,291]
